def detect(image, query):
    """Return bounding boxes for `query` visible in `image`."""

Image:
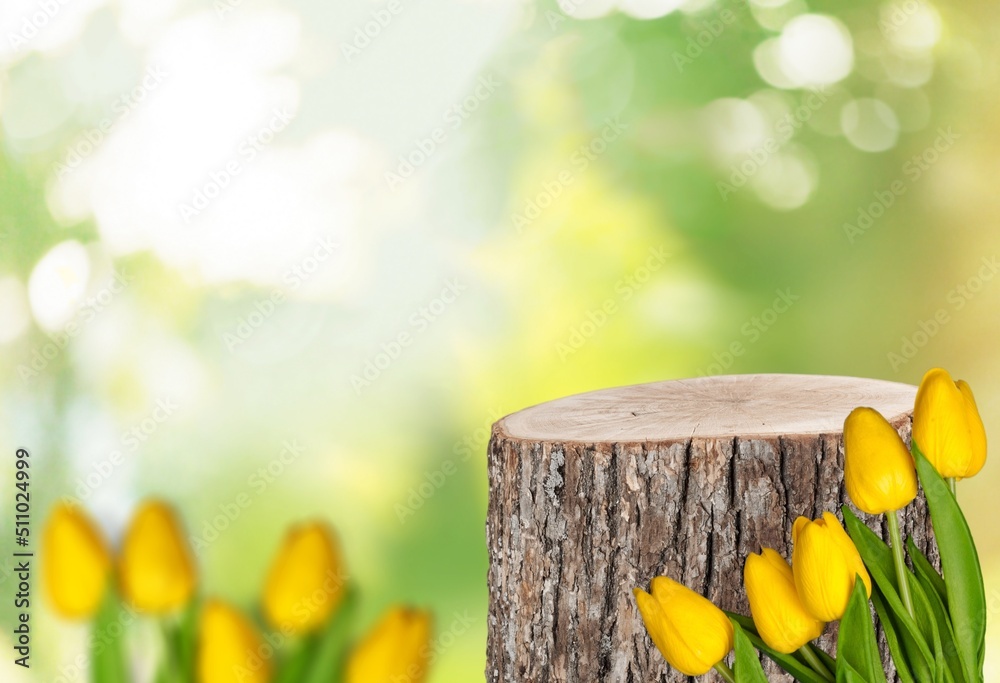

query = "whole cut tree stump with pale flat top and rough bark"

[486,375,938,683]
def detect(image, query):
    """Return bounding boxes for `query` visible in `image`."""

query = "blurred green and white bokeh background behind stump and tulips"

[0,0,1000,683]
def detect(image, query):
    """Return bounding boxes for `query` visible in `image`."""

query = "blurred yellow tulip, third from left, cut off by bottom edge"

[198,600,271,683]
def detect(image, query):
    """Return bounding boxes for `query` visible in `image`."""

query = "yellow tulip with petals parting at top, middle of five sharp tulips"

[792,512,872,621]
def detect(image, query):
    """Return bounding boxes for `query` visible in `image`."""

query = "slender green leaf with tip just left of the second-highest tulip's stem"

[843,505,936,681]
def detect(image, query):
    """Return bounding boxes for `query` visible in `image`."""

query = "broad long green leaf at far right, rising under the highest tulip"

[913,443,986,681]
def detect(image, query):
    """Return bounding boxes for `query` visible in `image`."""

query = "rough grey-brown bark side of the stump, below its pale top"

[486,376,938,683]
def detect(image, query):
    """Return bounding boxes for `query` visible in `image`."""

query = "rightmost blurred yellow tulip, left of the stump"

[347,607,432,683]
